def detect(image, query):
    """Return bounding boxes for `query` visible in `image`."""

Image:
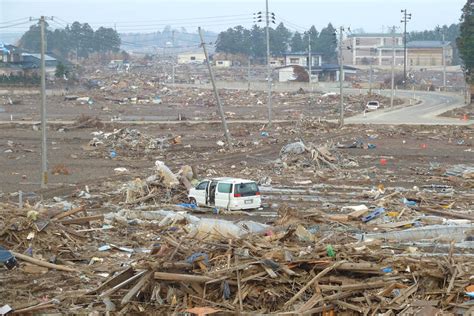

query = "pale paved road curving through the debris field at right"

[344,91,474,125]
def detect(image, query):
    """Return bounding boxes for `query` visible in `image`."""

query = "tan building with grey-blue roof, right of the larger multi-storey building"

[407,41,453,66]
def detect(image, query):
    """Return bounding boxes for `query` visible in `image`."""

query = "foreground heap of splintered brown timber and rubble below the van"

[0,198,474,314]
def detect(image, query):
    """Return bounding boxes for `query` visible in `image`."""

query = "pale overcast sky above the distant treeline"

[0,0,466,35]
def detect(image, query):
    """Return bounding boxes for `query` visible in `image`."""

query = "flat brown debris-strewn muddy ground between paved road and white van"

[0,119,474,212]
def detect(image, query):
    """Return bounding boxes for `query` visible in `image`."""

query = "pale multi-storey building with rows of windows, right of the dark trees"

[342,33,404,66]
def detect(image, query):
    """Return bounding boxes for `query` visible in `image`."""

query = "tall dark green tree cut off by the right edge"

[457,0,474,84]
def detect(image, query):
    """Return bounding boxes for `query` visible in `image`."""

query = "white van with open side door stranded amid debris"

[188,178,262,211]
